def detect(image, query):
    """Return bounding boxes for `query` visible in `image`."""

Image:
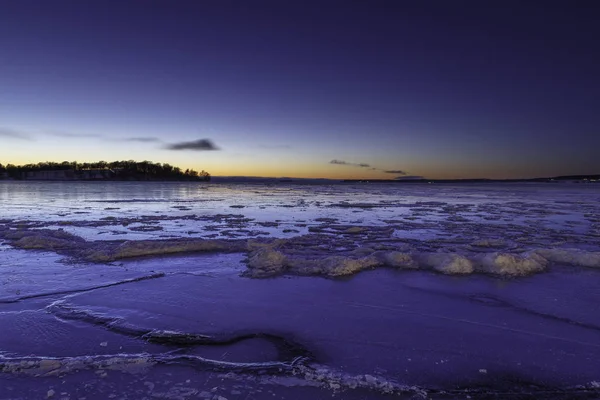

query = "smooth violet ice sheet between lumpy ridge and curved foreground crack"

[9,268,600,398]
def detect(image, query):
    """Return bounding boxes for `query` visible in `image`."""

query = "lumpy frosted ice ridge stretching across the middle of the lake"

[0,226,600,278]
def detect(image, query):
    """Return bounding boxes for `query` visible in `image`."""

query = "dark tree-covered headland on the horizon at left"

[0,160,210,181]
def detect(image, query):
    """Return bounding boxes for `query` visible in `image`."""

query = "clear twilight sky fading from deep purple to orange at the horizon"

[0,0,600,179]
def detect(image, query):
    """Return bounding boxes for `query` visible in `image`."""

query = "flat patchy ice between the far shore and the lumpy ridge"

[0,182,600,248]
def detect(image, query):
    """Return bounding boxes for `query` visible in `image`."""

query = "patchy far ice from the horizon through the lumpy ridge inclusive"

[0,180,600,278]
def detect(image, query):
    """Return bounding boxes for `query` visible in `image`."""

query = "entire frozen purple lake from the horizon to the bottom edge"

[0,182,600,399]
